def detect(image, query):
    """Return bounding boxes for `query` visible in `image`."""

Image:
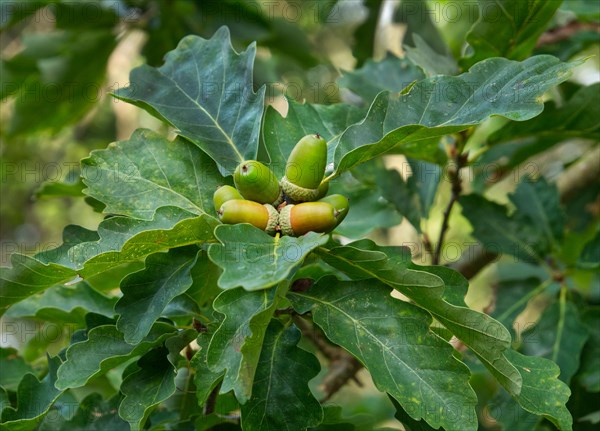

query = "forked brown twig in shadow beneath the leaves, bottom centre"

[294,316,362,403]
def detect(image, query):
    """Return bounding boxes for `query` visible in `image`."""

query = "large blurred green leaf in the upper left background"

[2,30,116,136]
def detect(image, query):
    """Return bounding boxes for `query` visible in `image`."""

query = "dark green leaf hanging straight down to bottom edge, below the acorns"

[242,320,323,431]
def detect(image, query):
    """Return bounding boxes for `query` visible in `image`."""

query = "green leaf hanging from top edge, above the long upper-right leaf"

[461,0,562,68]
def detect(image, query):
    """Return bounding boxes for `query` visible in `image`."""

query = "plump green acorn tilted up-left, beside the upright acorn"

[233,160,283,206]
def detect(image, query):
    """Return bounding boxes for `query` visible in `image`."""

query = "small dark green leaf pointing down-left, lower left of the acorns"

[115,247,198,344]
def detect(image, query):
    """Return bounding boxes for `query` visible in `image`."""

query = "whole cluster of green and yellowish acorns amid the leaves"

[213,134,349,236]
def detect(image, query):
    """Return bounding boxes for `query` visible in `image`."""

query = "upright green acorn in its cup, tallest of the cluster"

[281,133,327,202]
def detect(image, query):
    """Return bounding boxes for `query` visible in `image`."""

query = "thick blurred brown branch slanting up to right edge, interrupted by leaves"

[450,145,600,278]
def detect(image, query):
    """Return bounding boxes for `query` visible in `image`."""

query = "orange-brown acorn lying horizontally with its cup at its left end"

[279,202,338,236]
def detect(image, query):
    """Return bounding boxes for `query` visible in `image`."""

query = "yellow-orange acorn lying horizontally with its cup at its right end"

[217,199,279,234]
